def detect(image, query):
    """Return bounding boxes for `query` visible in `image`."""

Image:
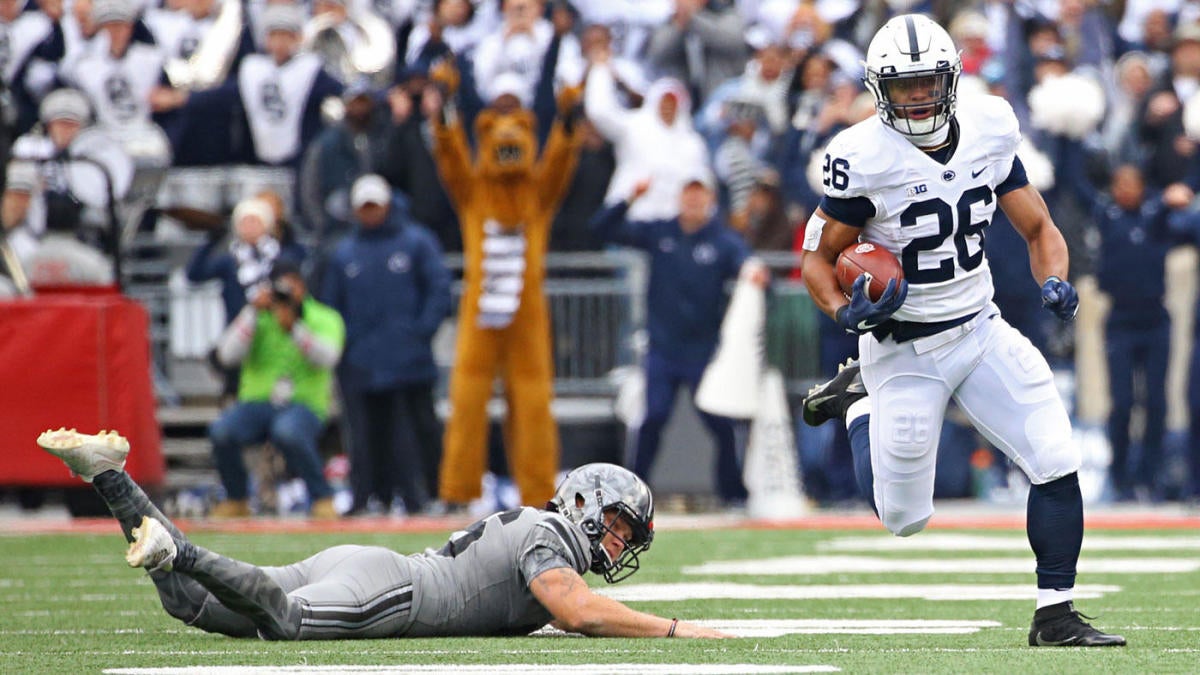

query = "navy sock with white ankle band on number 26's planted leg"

[1025,473,1084,598]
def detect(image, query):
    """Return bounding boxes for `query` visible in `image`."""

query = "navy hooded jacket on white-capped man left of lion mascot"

[319,198,451,392]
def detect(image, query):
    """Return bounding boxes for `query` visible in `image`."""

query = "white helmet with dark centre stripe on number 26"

[863,14,962,137]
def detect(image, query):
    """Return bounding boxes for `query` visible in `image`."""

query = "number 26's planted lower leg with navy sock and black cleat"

[1026,473,1126,647]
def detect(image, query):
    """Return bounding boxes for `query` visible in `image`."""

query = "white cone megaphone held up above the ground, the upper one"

[696,258,767,419]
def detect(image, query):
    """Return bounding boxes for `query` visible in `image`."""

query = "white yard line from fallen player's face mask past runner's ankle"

[595,583,1121,602]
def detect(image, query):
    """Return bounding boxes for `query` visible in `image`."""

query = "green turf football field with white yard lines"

[0,516,1200,675]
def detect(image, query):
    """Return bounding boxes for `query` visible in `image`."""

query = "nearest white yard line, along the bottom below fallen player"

[104,663,840,675]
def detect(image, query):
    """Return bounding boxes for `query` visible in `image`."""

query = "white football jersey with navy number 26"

[823,96,1021,322]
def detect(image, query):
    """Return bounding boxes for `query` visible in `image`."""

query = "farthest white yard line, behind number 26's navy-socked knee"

[817,532,1200,552]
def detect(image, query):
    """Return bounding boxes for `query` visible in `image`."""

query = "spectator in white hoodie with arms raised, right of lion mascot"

[583,52,708,220]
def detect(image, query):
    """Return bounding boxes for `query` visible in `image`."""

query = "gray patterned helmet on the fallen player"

[546,462,654,584]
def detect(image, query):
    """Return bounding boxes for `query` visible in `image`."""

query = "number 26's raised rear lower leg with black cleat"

[800,359,878,514]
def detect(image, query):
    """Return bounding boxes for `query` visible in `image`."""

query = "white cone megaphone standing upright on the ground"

[742,368,809,520]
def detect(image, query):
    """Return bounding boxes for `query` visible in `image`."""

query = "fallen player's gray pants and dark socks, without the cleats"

[92,472,413,640]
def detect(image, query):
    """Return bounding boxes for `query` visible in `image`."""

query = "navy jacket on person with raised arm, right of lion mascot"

[592,202,750,364]
